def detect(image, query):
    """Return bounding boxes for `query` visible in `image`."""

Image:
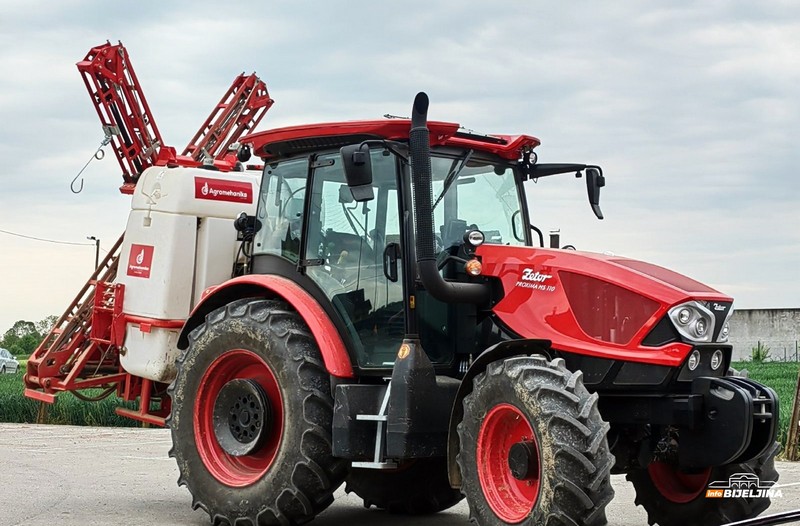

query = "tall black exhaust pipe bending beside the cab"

[408,92,489,304]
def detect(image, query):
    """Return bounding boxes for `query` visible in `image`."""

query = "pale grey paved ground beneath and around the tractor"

[0,424,800,526]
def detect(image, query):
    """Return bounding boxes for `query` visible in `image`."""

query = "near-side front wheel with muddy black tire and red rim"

[458,356,614,526]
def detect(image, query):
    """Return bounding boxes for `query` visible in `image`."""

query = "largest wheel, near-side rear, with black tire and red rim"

[168,299,347,525]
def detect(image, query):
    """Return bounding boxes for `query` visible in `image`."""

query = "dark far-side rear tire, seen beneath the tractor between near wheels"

[345,457,464,515]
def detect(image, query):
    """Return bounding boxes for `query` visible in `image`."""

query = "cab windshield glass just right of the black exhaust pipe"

[431,152,526,250]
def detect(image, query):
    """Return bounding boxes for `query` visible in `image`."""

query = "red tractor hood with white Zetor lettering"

[477,244,733,366]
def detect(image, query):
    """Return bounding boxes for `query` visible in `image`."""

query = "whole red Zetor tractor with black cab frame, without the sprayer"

[164,93,779,526]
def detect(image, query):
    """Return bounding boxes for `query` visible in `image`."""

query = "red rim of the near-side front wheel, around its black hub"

[476,404,542,524]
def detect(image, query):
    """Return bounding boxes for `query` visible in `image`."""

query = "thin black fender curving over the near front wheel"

[447,339,552,488]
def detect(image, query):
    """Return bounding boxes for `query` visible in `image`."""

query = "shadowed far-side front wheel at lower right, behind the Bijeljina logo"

[627,442,780,526]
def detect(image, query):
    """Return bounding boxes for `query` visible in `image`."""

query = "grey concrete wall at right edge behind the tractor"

[730,309,800,361]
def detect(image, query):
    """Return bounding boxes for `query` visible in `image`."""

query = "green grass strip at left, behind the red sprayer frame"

[0,367,138,427]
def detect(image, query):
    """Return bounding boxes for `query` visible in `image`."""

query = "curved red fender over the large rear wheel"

[183,274,355,378]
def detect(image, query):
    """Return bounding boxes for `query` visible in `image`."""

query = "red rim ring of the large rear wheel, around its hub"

[194,349,283,488]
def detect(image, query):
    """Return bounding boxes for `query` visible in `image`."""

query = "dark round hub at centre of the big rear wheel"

[214,378,272,457]
